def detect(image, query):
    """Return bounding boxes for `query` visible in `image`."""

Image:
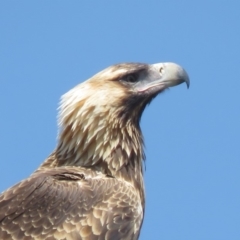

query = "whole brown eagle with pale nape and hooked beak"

[0,62,189,240]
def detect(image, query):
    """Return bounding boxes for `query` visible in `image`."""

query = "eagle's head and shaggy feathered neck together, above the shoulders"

[49,63,189,180]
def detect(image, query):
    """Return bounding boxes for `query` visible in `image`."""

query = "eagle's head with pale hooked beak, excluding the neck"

[59,63,189,126]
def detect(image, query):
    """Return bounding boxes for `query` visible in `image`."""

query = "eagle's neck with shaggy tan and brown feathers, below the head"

[42,106,144,202]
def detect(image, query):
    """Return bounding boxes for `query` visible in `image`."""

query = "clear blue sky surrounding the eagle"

[0,0,240,240]
